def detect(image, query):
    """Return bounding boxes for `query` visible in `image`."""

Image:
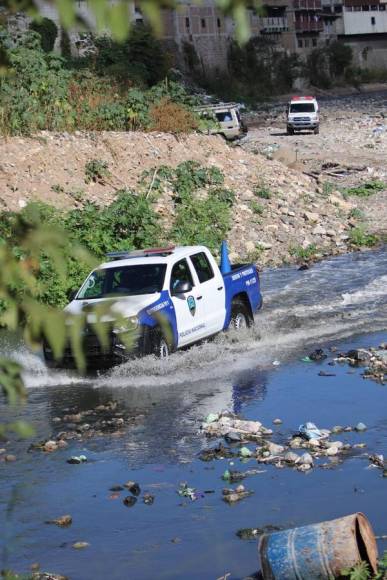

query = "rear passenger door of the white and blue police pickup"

[190,252,226,336]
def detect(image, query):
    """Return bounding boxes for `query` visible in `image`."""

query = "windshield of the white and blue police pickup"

[77,264,166,300]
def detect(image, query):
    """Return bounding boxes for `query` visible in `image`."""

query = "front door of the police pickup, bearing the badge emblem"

[169,259,206,347]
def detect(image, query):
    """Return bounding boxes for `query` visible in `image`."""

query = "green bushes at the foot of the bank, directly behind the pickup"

[0,160,235,307]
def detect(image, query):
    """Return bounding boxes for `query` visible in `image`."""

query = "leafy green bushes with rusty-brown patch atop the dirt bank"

[0,32,198,135]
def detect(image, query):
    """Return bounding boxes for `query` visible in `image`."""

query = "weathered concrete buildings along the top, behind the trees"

[6,0,387,74]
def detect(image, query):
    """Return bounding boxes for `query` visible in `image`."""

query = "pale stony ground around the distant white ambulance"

[242,91,387,233]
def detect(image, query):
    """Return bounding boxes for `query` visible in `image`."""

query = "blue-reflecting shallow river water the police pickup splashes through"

[0,247,387,580]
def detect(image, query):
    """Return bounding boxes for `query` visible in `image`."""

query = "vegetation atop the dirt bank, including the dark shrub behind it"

[0,27,199,135]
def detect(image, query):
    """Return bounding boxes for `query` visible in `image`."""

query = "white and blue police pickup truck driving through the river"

[44,243,262,366]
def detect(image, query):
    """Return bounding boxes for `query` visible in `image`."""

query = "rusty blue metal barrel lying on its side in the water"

[258,513,378,580]
